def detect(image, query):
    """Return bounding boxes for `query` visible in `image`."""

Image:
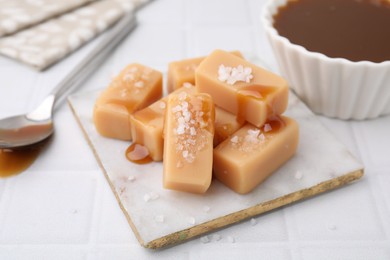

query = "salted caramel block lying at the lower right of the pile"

[213,116,299,194]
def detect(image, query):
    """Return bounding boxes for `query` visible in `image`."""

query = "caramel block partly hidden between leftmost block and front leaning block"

[130,83,196,161]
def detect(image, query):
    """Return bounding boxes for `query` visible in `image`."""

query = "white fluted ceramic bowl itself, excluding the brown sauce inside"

[261,0,390,120]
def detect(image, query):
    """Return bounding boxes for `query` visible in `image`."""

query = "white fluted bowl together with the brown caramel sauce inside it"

[261,0,390,120]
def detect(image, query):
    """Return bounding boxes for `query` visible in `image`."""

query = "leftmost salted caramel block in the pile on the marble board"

[93,64,162,140]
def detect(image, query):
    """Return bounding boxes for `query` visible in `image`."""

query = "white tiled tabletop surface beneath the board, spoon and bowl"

[0,0,390,260]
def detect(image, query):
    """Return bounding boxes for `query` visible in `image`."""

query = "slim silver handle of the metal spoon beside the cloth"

[49,12,136,102]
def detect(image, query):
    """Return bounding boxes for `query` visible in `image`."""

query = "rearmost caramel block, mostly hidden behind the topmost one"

[168,51,243,93]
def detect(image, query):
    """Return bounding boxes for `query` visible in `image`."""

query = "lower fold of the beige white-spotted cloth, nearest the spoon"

[0,0,148,70]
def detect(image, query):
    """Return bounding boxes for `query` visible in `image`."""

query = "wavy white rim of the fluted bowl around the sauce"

[260,0,390,68]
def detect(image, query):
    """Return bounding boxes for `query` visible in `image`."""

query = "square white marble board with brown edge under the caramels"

[69,91,363,249]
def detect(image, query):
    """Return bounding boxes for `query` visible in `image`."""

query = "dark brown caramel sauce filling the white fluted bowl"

[274,0,390,62]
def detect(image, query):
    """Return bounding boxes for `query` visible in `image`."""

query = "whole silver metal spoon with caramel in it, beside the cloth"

[0,13,136,149]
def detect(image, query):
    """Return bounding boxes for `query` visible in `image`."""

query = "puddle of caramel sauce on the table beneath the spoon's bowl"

[0,140,47,178]
